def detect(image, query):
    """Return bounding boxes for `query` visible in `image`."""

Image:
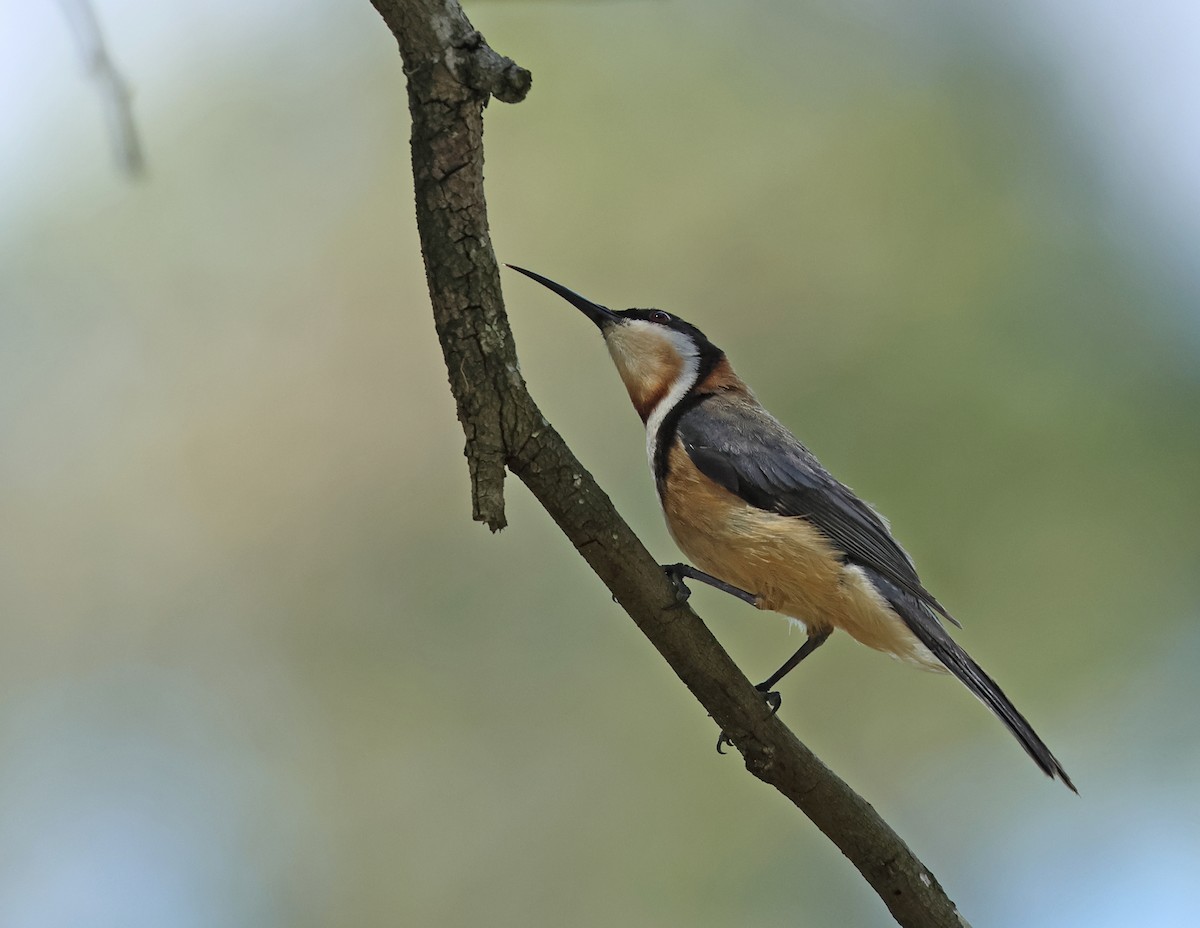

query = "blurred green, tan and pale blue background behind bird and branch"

[0,0,1200,928]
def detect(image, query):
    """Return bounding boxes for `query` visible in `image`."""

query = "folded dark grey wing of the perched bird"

[677,394,959,625]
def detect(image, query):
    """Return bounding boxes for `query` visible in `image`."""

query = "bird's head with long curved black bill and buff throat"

[509,264,725,421]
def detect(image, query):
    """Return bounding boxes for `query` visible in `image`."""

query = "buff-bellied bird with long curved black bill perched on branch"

[508,264,1078,794]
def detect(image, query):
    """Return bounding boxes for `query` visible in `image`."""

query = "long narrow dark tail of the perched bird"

[870,571,1079,794]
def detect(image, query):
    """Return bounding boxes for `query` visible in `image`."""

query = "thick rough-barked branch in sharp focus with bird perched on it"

[372,0,966,928]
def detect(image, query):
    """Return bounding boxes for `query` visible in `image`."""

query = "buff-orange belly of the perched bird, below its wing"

[662,445,946,671]
